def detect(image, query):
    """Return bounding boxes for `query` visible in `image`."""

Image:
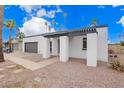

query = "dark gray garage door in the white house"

[25,42,38,53]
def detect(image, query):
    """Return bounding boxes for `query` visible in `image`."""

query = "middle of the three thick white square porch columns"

[60,36,69,62]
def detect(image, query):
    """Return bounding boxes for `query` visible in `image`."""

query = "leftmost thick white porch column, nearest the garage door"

[43,37,50,58]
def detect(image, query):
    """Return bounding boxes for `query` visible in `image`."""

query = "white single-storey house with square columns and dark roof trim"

[23,25,108,67]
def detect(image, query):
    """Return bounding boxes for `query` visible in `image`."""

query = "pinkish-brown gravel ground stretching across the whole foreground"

[0,51,124,88]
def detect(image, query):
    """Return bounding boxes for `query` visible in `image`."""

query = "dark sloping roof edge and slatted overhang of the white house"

[25,25,108,38]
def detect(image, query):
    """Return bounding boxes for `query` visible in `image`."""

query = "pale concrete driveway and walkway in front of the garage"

[4,52,59,71]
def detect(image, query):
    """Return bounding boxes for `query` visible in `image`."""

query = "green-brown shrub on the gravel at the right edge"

[110,60,124,72]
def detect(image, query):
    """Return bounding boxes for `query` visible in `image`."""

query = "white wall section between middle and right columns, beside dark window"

[69,36,87,59]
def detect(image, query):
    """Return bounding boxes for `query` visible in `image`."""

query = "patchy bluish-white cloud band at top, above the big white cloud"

[19,5,63,18]
